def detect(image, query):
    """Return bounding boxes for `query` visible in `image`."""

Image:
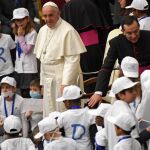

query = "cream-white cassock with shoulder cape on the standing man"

[34,18,86,116]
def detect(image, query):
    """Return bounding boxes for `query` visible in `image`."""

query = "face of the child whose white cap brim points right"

[118,88,137,103]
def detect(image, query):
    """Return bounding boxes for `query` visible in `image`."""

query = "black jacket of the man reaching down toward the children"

[95,31,150,96]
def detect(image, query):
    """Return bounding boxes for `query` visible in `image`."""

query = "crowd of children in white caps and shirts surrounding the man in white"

[0,1,150,150]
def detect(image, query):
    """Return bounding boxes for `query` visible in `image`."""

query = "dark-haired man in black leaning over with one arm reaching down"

[88,16,150,107]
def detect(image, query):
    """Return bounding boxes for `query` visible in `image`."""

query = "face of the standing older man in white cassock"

[42,6,60,28]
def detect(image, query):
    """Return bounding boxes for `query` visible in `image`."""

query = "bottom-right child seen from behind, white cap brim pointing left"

[107,112,141,150]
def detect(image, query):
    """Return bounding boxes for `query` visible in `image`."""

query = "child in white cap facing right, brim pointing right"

[104,77,139,150]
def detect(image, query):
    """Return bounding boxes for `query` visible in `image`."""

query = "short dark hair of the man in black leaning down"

[121,16,140,29]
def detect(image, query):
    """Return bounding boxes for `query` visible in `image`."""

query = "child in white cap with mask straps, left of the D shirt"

[34,117,77,150]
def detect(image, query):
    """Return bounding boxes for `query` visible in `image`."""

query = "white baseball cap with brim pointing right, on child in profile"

[111,77,139,94]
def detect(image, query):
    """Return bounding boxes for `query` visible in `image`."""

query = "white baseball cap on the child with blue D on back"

[56,85,83,102]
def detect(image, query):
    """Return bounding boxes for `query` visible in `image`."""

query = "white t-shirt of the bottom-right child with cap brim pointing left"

[114,138,141,150]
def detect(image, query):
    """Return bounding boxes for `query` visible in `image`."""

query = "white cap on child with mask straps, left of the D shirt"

[34,117,58,139]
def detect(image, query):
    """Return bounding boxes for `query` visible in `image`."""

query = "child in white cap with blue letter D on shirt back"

[56,85,94,150]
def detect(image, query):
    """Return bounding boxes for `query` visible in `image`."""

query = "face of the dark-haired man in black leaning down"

[122,21,140,43]
